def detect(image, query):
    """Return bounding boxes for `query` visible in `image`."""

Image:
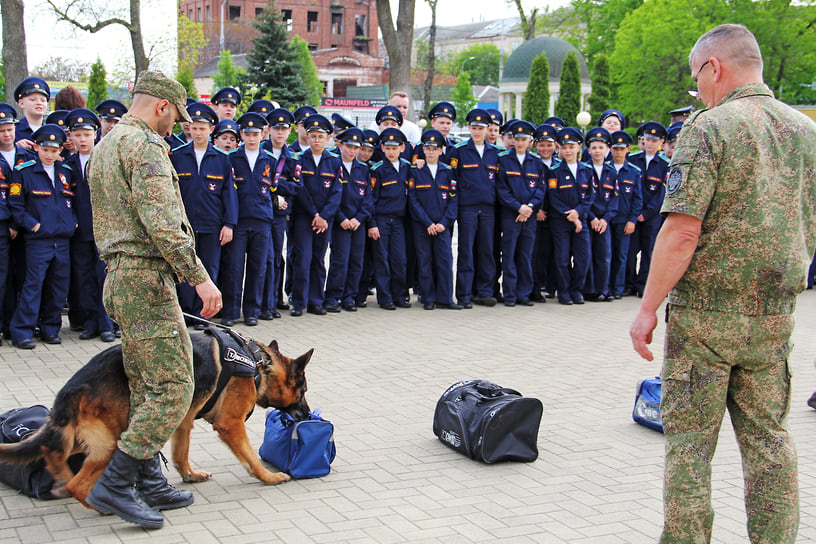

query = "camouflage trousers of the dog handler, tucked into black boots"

[103,258,194,459]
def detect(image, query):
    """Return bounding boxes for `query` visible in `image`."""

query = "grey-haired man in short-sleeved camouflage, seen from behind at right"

[630,25,816,543]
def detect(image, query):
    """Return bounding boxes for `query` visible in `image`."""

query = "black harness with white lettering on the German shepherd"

[196,327,263,419]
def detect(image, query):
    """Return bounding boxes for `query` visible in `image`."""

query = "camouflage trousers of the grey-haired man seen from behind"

[660,305,799,544]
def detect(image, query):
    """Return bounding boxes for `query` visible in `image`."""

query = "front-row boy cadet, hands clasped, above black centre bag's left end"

[408,129,463,310]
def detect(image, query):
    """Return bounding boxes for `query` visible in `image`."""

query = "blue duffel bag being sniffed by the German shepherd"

[258,409,337,478]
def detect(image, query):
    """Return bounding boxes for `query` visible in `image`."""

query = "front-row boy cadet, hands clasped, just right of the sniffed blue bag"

[324,127,374,312]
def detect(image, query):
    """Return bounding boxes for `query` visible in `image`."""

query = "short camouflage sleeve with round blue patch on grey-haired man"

[660,112,720,220]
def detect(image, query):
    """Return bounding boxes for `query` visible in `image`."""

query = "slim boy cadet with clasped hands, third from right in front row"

[585,127,618,302]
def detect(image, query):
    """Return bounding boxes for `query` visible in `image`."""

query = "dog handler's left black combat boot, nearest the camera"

[87,449,164,529]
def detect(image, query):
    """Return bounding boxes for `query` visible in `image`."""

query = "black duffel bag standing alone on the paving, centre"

[433,380,543,463]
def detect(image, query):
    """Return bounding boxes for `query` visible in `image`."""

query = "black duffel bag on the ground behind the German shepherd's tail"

[0,404,85,500]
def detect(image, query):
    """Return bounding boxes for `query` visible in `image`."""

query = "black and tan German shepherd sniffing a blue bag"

[0,334,314,506]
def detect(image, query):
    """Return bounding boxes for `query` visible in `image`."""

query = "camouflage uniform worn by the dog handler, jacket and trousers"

[89,101,208,459]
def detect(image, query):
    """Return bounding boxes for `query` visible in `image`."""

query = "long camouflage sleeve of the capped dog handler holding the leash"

[131,140,209,285]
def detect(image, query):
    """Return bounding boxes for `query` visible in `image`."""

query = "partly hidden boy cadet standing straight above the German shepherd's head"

[259,108,298,321]
